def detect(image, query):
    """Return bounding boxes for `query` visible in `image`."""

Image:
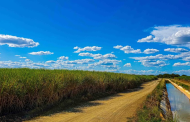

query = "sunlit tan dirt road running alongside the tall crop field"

[25,80,158,122]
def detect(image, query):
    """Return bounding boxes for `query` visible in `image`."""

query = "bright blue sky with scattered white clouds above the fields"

[0,0,190,75]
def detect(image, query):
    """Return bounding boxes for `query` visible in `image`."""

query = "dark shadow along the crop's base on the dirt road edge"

[0,85,144,122]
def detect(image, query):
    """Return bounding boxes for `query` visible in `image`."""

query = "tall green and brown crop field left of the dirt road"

[0,68,156,115]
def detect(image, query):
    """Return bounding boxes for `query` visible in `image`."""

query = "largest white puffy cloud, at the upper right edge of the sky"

[138,25,190,48]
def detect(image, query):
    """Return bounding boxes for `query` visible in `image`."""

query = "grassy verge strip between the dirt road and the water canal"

[130,79,173,122]
